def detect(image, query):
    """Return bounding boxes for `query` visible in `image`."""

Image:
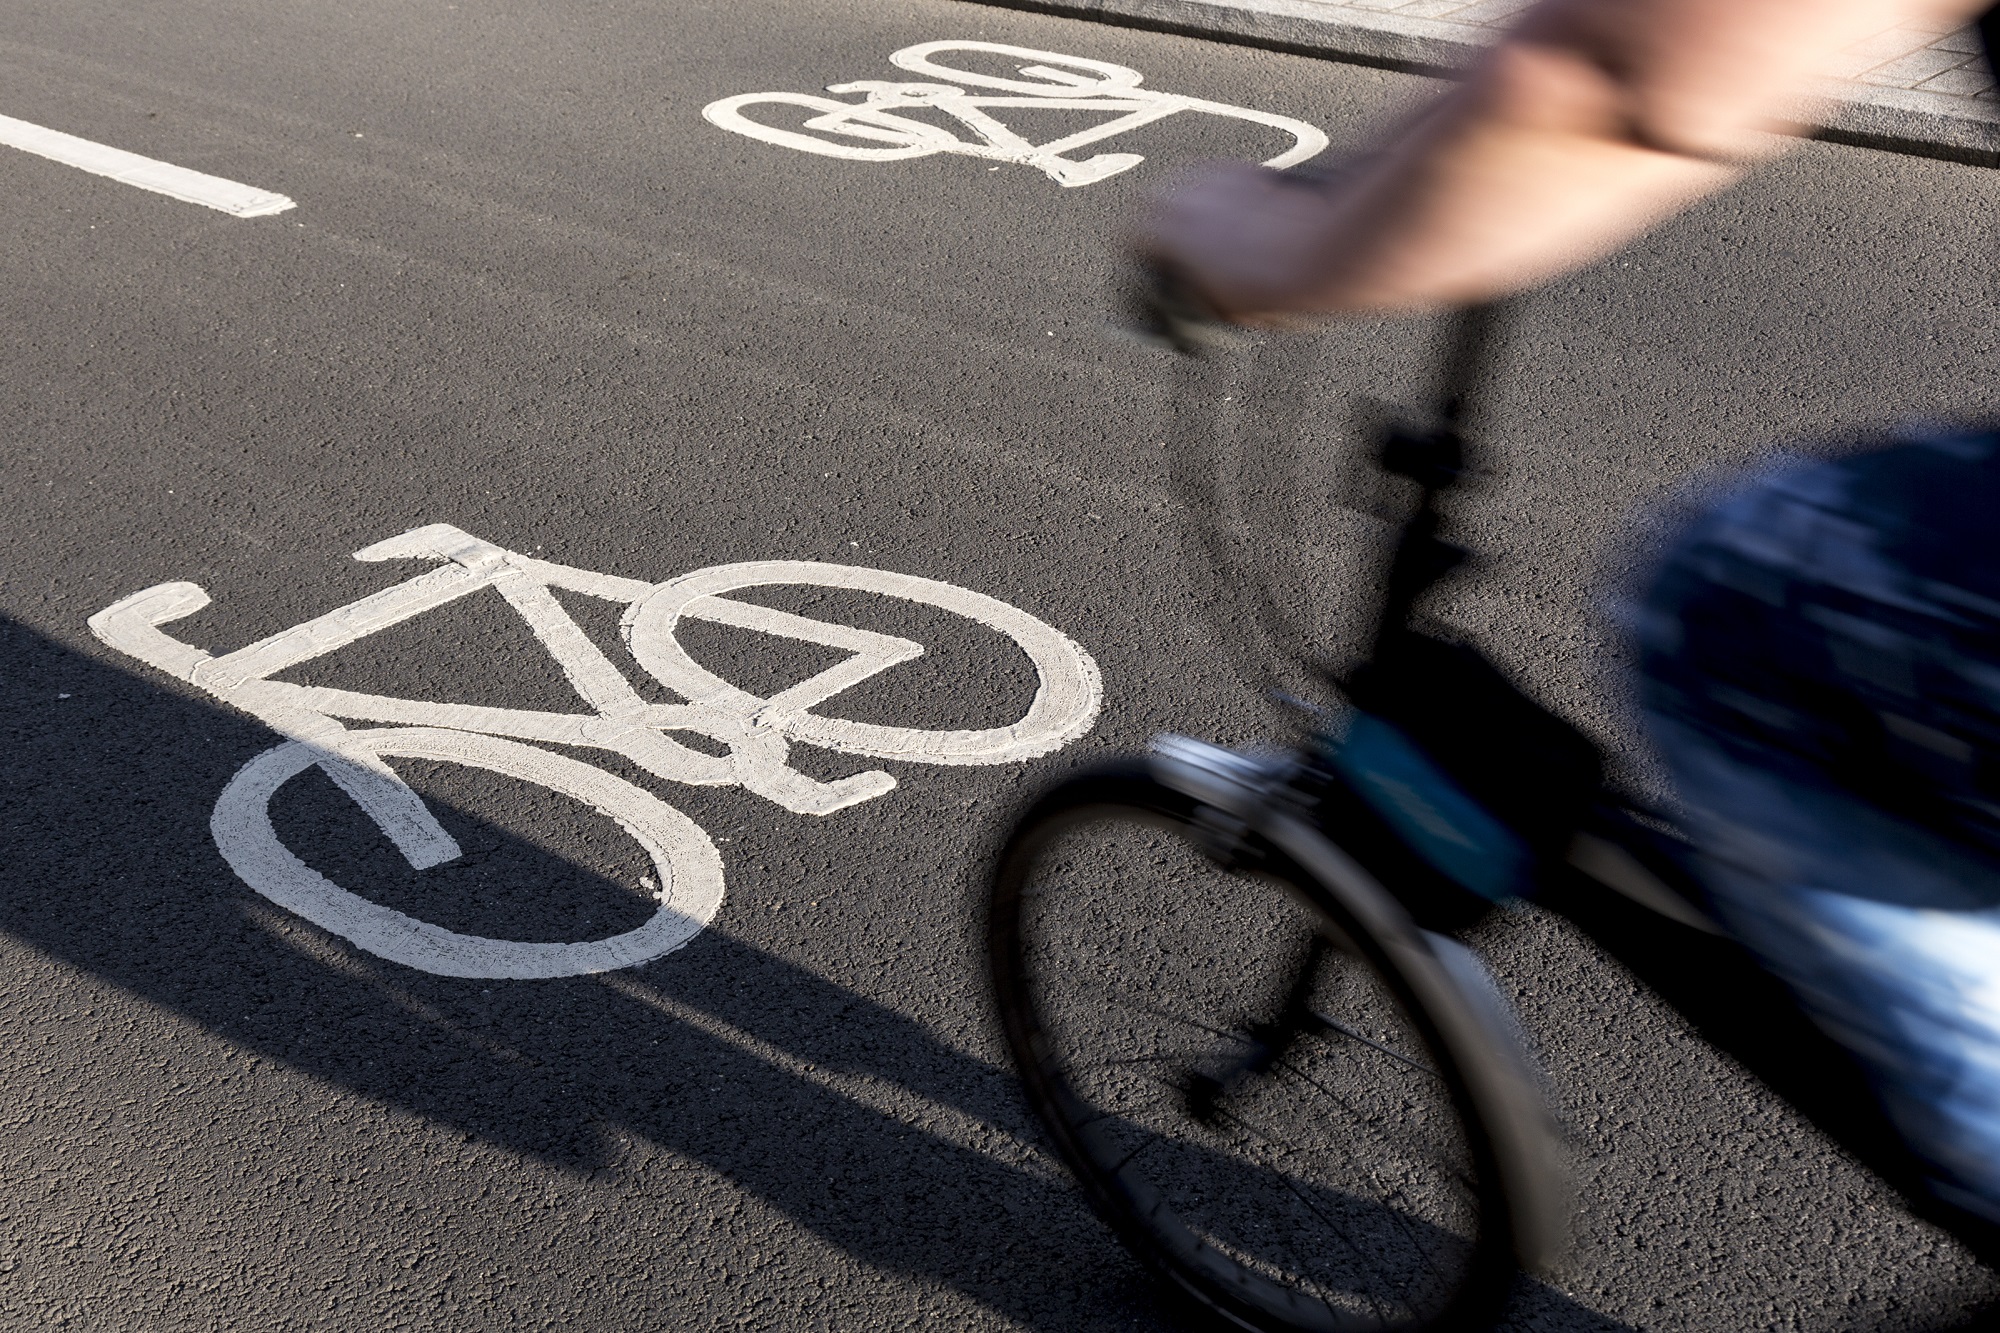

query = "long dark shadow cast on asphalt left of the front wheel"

[0,620,1624,1333]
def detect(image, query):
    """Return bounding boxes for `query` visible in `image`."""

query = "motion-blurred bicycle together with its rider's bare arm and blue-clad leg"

[990,0,2000,1329]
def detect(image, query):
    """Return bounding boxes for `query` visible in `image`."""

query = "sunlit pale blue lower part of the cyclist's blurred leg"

[1654,723,2000,1223]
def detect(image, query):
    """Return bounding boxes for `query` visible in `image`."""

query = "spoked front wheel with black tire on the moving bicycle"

[988,767,1514,1333]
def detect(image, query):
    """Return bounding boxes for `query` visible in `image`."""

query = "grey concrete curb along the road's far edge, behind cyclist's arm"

[970,0,2000,166]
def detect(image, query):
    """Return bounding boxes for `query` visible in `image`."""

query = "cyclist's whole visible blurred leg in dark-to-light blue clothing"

[1640,436,2000,1221]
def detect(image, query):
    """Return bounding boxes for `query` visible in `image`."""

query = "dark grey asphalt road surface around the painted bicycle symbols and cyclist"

[11,0,2000,1333]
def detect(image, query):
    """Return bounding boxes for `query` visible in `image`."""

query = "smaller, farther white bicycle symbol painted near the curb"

[702,42,1326,186]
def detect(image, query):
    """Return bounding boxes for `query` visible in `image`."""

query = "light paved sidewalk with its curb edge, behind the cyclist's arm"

[978,0,2000,166]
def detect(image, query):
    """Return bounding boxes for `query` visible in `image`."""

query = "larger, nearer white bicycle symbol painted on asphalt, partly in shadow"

[90,522,1102,979]
